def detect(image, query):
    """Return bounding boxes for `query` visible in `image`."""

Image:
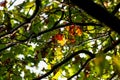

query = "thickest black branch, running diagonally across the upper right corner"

[71,0,120,34]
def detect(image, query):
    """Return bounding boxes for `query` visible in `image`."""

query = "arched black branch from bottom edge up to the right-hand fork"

[33,50,95,80]
